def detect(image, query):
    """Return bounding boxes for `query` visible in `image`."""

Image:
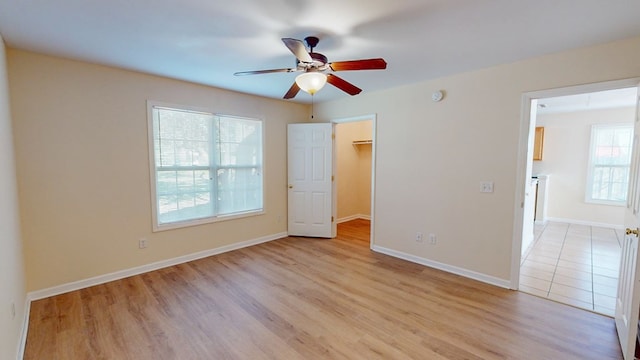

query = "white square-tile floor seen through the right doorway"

[520,222,624,316]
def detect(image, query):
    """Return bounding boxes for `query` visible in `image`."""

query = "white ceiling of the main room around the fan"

[0,0,640,102]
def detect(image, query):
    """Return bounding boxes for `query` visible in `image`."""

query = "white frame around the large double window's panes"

[147,100,265,232]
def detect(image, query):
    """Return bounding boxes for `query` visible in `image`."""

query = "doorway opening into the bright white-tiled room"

[517,79,637,317]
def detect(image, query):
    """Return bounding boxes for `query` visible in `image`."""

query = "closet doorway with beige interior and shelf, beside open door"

[332,115,376,246]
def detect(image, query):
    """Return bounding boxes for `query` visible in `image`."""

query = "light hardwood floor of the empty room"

[25,220,621,360]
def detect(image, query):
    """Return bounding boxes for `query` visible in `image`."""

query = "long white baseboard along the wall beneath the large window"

[25,232,287,300]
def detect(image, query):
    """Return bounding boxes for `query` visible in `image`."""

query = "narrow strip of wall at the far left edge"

[0,37,26,359]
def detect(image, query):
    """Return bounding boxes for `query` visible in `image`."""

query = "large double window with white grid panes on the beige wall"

[149,103,263,230]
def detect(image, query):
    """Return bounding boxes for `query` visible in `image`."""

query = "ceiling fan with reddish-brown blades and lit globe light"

[234,36,387,99]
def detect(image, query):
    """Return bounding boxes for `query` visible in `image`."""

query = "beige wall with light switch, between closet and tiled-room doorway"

[316,37,640,284]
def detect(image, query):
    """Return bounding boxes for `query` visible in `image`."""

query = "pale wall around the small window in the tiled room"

[533,107,635,227]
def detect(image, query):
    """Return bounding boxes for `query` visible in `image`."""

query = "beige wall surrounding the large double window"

[8,49,308,291]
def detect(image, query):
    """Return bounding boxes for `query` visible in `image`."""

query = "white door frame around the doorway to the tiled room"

[510,78,640,290]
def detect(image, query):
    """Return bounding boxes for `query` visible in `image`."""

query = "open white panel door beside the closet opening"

[287,123,335,238]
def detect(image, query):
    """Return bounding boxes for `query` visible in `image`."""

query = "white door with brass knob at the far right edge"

[615,83,640,360]
